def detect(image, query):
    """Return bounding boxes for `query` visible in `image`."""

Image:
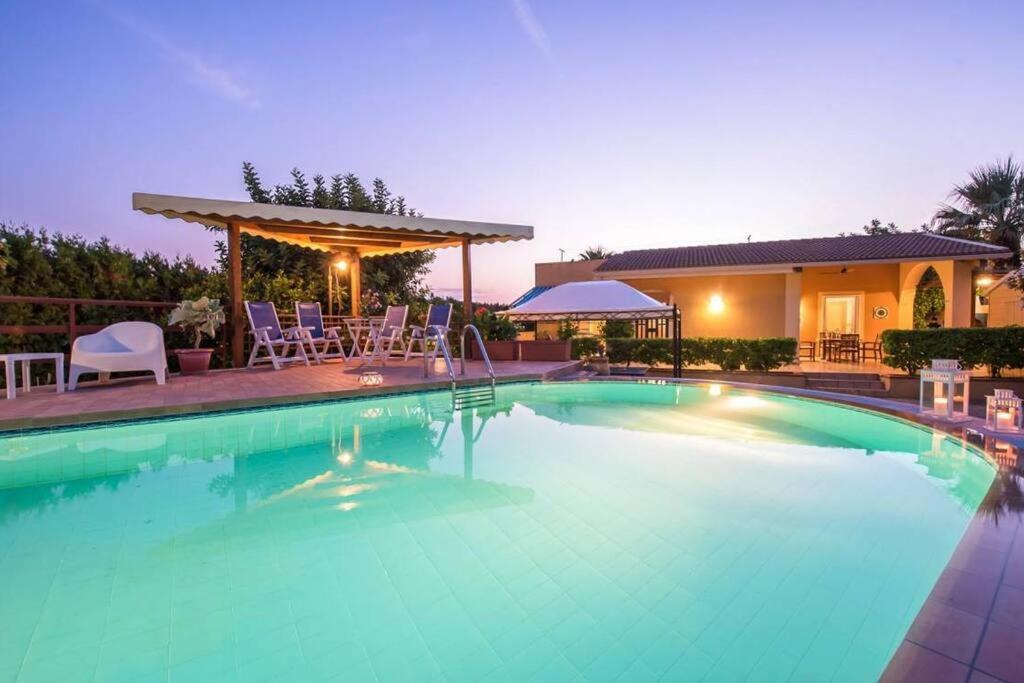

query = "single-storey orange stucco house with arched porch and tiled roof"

[523,232,1011,340]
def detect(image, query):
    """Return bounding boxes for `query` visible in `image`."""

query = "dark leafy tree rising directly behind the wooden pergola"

[232,162,434,313]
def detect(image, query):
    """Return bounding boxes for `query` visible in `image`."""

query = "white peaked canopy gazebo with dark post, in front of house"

[501,280,682,377]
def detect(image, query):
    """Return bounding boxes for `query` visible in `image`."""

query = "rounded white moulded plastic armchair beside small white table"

[68,322,167,391]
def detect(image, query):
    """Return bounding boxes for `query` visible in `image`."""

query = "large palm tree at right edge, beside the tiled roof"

[931,157,1024,264]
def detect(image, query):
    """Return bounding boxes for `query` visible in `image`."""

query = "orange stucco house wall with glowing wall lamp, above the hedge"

[624,273,785,338]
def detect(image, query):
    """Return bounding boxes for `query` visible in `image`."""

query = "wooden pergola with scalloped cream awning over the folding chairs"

[132,193,534,368]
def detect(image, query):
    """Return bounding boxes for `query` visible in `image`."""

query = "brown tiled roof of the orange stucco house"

[597,232,1010,272]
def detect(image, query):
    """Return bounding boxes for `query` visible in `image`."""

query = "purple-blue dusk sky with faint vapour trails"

[0,0,1024,301]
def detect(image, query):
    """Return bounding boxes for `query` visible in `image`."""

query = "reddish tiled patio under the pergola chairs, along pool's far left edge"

[0,359,577,431]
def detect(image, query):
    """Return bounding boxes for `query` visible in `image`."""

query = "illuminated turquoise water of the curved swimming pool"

[0,383,993,681]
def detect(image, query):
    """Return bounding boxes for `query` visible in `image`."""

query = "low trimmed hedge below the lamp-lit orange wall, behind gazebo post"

[605,337,797,373]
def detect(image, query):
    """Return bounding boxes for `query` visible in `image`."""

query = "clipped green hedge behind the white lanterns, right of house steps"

[882,326,1024,377]
